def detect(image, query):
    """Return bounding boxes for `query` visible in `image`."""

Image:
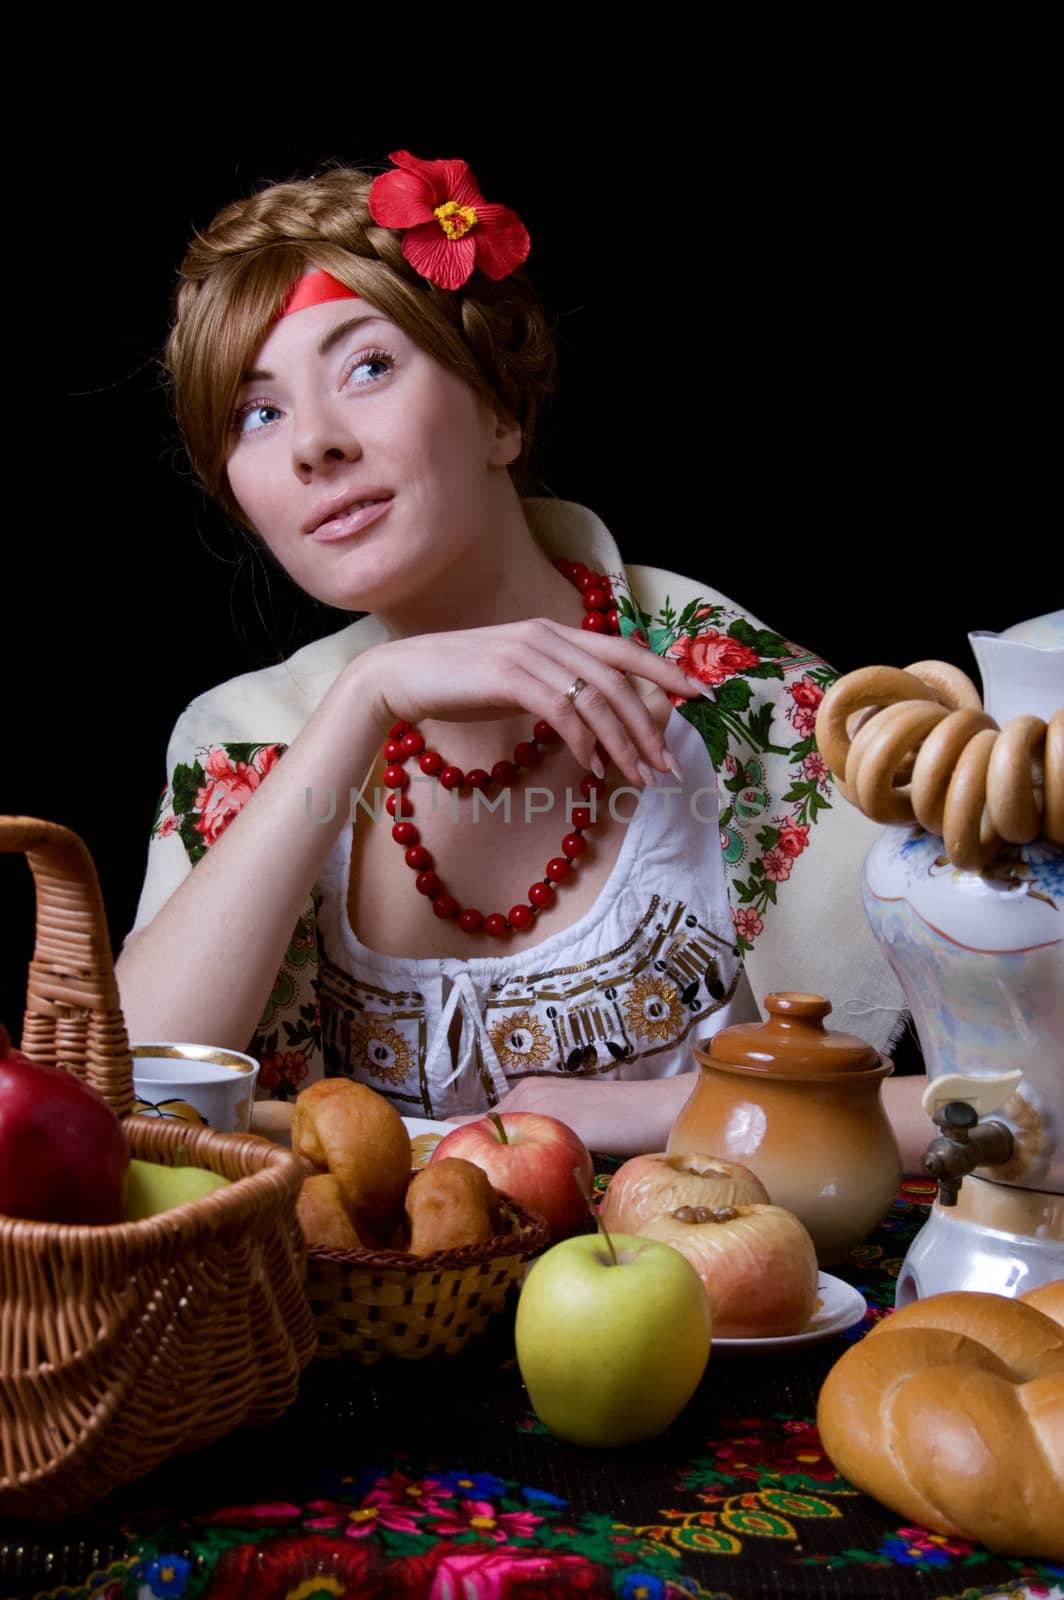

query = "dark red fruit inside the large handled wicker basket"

[0,1029,130,1222]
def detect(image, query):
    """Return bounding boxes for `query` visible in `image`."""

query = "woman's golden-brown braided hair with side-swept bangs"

[165,168,555,520]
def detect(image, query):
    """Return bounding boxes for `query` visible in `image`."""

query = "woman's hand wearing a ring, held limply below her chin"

[358,618,698,784]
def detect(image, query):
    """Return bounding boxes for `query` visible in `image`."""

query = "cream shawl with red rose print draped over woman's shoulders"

[134,501,904,1096]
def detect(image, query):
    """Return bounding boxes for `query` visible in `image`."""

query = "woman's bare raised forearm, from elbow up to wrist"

[117,662,382,1050]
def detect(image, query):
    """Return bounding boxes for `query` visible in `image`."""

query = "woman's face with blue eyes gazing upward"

[227,299,520,613]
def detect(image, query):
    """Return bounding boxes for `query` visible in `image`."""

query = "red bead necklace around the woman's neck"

[384,558,621,939]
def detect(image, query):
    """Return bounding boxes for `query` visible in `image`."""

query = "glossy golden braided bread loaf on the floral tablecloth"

[816,1280,1064,1560]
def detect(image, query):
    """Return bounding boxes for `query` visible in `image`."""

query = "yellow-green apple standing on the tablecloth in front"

[517,1234,710,1446]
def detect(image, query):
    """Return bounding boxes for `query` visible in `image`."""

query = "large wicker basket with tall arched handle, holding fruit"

[0,818,315,1518]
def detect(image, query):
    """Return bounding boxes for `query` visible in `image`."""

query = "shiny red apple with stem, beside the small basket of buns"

[430,1110,595,1242]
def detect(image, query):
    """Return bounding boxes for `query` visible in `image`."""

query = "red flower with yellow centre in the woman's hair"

[370,150,531,290]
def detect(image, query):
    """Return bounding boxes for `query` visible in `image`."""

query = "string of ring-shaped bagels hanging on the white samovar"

[816,661,1064,872]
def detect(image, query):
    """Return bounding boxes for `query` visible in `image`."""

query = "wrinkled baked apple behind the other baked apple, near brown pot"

[598,1150,768,1234]
